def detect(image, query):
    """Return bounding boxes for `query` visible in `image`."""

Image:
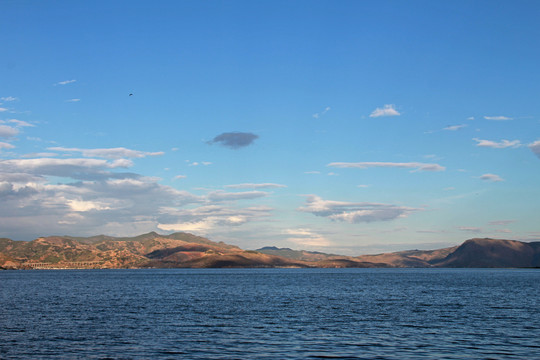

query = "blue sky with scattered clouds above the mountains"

[0,0,540,255]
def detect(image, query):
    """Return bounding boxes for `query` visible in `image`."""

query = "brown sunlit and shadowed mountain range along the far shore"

[0,232,540,269]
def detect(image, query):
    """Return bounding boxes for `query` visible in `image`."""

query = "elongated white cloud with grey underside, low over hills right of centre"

[298,195,420,224]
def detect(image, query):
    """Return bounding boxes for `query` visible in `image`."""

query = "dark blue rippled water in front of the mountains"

[0,269,540,359]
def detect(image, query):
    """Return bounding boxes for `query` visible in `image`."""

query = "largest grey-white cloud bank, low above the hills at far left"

[0,154,209,239]
